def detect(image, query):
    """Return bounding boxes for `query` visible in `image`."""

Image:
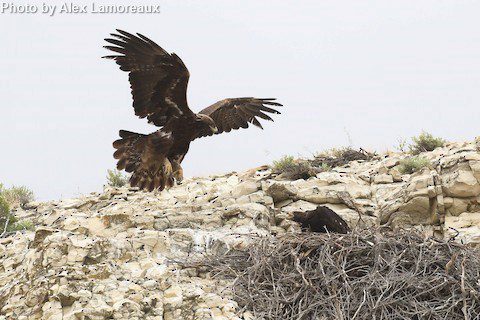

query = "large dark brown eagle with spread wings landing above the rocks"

[103,30,282,191]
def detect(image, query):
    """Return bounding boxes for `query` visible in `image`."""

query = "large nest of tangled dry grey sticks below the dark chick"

[207,230,480,320]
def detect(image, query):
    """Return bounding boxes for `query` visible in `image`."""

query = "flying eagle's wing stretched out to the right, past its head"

[197,97,282,138]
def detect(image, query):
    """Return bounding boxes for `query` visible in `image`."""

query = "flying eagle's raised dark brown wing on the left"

[104,29,194,126]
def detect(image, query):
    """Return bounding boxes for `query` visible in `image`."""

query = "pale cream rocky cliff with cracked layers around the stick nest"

[0,142,480,320]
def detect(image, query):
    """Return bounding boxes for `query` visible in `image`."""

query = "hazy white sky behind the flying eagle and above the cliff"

[0,0,480,199]
